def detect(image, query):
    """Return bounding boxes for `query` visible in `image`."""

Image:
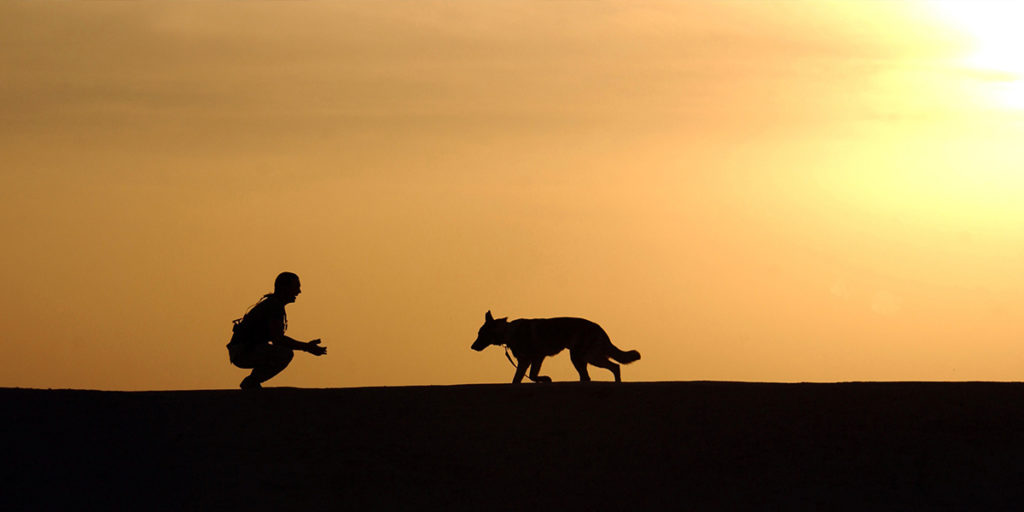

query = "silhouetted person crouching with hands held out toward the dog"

[227,272,327,389]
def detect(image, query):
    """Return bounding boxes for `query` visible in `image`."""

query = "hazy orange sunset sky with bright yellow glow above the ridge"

[0,0,1024,389]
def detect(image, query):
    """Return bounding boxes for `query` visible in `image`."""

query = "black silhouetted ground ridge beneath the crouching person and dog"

[0,382,1024,510]
